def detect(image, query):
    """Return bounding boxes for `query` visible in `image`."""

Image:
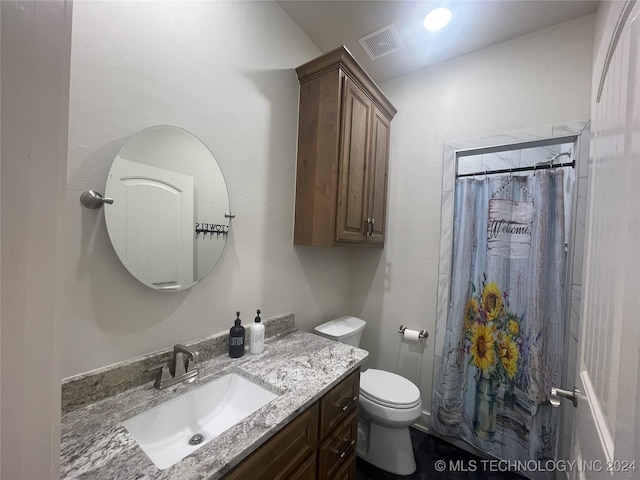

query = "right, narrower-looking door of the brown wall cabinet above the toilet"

[367,107,391,243]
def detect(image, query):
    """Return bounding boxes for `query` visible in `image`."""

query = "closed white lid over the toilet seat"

[360,368,421,408]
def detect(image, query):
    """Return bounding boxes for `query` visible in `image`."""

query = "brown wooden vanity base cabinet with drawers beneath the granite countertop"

[224,368,360,480]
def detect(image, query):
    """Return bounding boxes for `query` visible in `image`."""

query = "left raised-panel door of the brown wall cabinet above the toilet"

[336,77,373,242]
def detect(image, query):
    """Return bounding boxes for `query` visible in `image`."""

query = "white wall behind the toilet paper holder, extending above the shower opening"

[351,15,595,411]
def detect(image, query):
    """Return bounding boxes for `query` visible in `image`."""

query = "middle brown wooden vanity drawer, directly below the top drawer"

[318,411,358,480]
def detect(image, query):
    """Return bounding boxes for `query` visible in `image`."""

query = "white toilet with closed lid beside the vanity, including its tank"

[315,316,422,475]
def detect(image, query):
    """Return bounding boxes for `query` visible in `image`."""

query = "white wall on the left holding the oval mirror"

[61,1,350,377]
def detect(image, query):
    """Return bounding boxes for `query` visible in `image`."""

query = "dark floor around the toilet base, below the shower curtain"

[356,428,523,480]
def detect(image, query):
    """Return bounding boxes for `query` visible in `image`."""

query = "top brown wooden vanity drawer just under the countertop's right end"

[320,368,360,441]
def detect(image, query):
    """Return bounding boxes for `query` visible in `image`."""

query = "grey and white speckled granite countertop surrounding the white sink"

[60,330,368,480]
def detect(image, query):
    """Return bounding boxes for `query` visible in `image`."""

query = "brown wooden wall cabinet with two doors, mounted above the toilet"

[293,46,397,246]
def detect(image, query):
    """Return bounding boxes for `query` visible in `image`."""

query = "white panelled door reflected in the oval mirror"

[105,158,195,290]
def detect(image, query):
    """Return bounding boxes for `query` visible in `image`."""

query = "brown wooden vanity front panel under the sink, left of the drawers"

[224,403,318,480]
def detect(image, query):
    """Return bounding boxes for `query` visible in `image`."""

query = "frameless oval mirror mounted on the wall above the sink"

[104,125,230,291]
